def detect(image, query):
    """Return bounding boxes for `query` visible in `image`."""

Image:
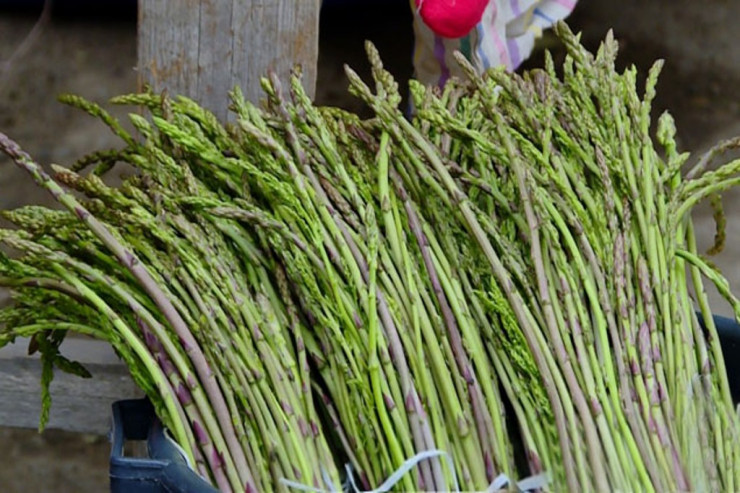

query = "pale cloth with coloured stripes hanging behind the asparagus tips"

[411,0,577,86]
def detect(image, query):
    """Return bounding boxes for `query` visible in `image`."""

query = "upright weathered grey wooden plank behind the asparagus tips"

[138,0,321,119]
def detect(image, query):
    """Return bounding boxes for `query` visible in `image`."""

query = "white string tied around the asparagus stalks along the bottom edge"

[280,450,550,493]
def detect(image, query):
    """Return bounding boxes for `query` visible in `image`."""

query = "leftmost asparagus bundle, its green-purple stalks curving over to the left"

[0,114,339,491]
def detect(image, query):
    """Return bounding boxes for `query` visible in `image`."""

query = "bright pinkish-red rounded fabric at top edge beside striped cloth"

[416,0,488,39]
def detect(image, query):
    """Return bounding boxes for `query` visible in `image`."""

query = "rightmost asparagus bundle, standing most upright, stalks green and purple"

[353,25,740,491]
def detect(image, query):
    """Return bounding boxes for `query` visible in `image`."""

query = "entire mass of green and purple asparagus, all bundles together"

[0,21,740,491]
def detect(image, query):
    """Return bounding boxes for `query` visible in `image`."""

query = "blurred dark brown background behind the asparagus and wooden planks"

[0,0,740,493]
